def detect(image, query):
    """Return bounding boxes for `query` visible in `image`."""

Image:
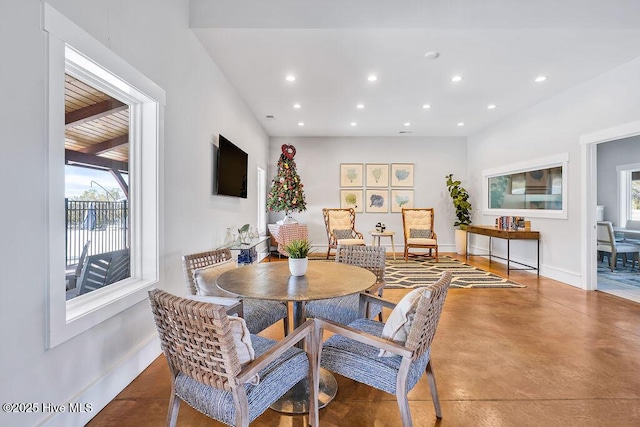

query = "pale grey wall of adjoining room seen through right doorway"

[597,136,640,226]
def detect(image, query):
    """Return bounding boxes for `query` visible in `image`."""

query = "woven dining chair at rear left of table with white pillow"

[182,249,289,335]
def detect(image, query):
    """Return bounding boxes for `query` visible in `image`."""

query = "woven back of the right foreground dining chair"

[405,271,451,360]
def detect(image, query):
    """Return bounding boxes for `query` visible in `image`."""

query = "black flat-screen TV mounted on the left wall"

[214,135,249,199]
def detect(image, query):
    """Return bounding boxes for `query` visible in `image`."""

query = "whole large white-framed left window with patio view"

[43,3,165,348]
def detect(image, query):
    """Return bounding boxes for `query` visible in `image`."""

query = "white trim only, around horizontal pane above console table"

[482,153,569,219]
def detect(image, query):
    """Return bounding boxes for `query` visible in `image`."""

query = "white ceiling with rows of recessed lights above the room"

[190,0,640,136]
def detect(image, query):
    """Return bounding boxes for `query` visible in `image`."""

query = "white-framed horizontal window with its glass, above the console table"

[483,153,569,219]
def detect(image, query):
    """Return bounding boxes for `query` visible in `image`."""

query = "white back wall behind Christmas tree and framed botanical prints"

[267,137,473,252]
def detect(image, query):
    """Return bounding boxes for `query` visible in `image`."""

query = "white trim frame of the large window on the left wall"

[43,3,166,348]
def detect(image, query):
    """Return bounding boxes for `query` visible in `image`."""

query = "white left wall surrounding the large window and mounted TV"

[0,0,268,426]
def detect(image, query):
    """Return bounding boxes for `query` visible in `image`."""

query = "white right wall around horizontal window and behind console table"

[468,60,640,286]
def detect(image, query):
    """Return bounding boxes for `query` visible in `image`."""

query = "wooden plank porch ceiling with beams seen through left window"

[65,74,129,165]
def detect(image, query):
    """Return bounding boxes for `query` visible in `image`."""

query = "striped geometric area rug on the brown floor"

[384,256,526,289]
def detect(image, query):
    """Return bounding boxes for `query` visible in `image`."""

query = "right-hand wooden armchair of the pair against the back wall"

[402,208,438,262]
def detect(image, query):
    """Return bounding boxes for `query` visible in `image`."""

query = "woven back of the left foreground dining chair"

[149,289,241,391]
